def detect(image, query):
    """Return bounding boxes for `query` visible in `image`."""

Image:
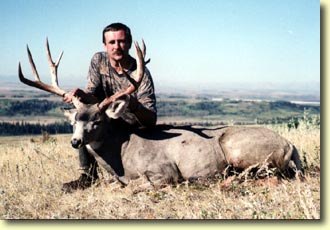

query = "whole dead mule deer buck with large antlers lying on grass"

[18,39,303,189]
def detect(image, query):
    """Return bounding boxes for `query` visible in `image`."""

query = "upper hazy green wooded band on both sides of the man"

[0,99,320,118]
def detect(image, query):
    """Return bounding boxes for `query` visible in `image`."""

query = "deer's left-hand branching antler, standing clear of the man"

[18,39,66,97]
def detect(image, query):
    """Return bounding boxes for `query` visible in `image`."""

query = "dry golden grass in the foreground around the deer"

[0,127,321,219]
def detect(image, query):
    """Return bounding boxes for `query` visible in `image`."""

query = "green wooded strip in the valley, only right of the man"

[157,100,320,117]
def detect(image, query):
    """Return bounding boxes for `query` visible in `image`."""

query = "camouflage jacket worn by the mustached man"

[85,52,157,126]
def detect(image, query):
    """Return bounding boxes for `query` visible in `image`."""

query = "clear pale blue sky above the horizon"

[0,0,320,90]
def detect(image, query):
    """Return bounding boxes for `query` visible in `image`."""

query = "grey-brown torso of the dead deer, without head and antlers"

[70,112,301,184]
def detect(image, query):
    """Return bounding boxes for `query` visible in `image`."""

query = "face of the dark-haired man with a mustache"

[104,30,130,61]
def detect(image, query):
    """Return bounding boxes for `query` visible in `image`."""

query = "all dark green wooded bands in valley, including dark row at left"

[0,99,320,136]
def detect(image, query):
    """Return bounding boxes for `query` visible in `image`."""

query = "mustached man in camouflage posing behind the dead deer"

[62,23,157,191]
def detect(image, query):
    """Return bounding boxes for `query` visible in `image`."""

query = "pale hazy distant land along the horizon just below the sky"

[0,75,320,101]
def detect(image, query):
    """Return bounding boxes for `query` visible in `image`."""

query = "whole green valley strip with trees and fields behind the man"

[0,94,320,136]
